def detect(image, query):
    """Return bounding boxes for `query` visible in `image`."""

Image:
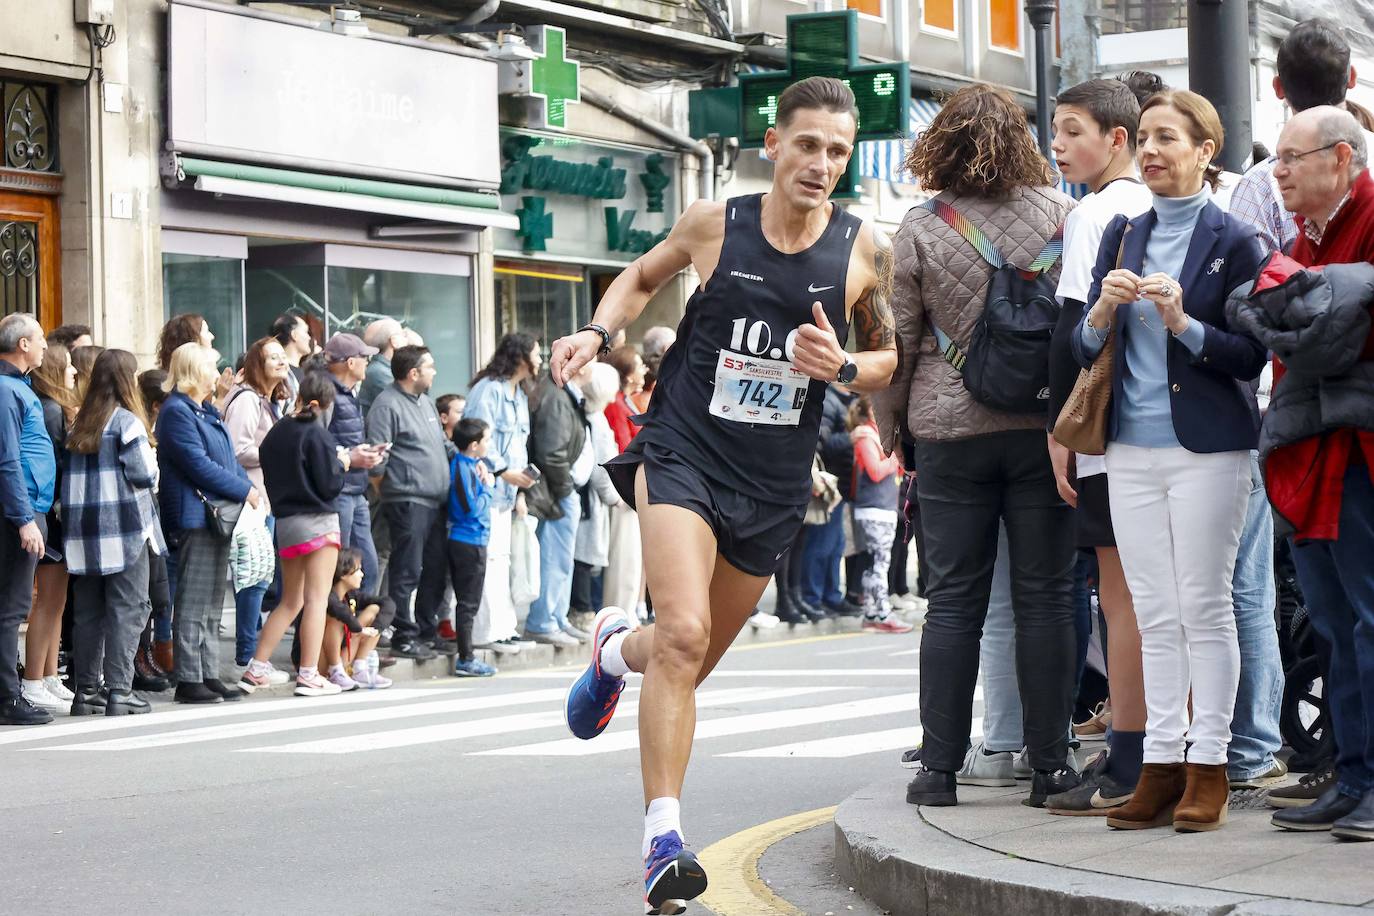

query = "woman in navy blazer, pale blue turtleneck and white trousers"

[1072,91,1265,831]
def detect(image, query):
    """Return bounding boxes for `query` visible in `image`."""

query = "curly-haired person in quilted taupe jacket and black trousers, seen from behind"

[874,85,1079,806]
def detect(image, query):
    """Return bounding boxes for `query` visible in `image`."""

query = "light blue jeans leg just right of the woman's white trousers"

[1226,452,1283,779]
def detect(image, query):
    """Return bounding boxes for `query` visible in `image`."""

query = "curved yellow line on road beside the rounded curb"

[697,807,838,916]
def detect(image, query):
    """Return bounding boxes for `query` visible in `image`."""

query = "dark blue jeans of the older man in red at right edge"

[1293,461,1374,797]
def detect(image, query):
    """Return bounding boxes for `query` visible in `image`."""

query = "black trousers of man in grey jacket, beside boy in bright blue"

[382,503,448,645]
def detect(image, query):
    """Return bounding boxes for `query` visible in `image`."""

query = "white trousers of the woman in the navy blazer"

[1107,444,1250,764]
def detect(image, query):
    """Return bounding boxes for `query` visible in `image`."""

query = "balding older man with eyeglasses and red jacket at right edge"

[1257,106,1374,840]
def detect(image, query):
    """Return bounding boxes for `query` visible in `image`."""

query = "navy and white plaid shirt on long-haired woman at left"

[62,407,168,575]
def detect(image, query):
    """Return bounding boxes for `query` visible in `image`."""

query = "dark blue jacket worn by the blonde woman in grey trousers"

[157,391,253,536]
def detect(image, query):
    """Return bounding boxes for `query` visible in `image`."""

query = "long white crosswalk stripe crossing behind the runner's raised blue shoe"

[251,687,840,754]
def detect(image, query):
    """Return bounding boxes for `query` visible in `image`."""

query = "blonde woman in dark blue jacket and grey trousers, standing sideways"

[157,343,258,703]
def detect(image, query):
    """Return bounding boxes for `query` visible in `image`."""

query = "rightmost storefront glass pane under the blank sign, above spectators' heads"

[328,266,474,397]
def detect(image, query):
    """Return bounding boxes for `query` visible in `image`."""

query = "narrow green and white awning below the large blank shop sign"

[179,157,519,229]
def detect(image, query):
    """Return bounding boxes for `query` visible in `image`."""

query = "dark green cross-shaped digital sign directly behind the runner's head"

[739,10,911,147]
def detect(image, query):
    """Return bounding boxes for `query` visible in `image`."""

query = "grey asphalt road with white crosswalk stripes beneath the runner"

[0,634,934,915]
